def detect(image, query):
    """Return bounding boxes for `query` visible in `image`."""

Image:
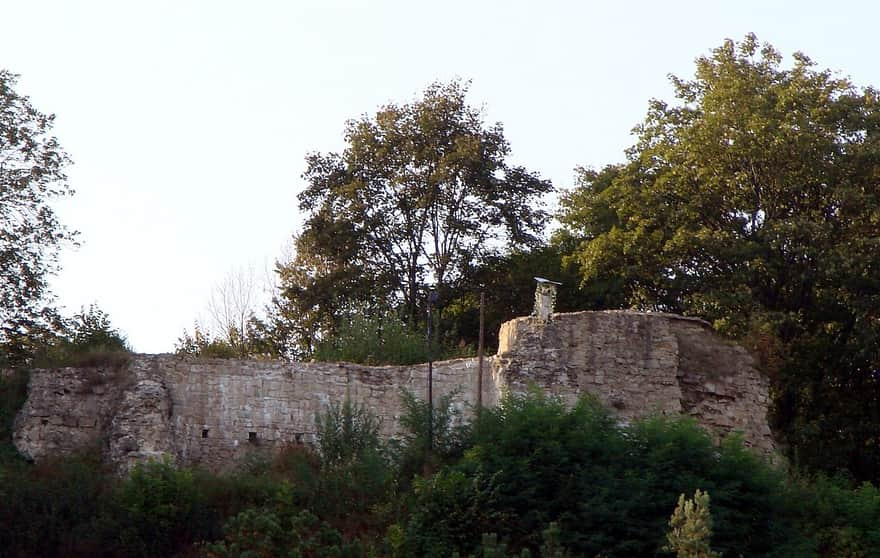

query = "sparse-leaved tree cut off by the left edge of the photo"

[0,70,75,364]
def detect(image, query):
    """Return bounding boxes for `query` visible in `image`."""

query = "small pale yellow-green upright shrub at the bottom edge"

[663,489,721,558]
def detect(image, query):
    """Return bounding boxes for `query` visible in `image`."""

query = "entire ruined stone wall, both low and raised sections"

[14,312,773,471]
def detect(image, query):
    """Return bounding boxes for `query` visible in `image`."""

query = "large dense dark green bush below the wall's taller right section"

[407,393,804,557]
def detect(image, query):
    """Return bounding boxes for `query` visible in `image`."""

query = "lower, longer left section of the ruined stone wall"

[14,355,476,470]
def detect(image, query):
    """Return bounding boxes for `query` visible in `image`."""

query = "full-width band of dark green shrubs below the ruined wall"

[0,393,880,558]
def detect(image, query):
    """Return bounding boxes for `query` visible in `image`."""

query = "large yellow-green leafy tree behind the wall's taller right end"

[560,35,880,479]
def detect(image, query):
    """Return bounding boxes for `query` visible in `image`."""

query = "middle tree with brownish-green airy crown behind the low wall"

[279,82,552,354]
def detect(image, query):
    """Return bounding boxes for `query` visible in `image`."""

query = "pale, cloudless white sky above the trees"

[0,0,880,352]
